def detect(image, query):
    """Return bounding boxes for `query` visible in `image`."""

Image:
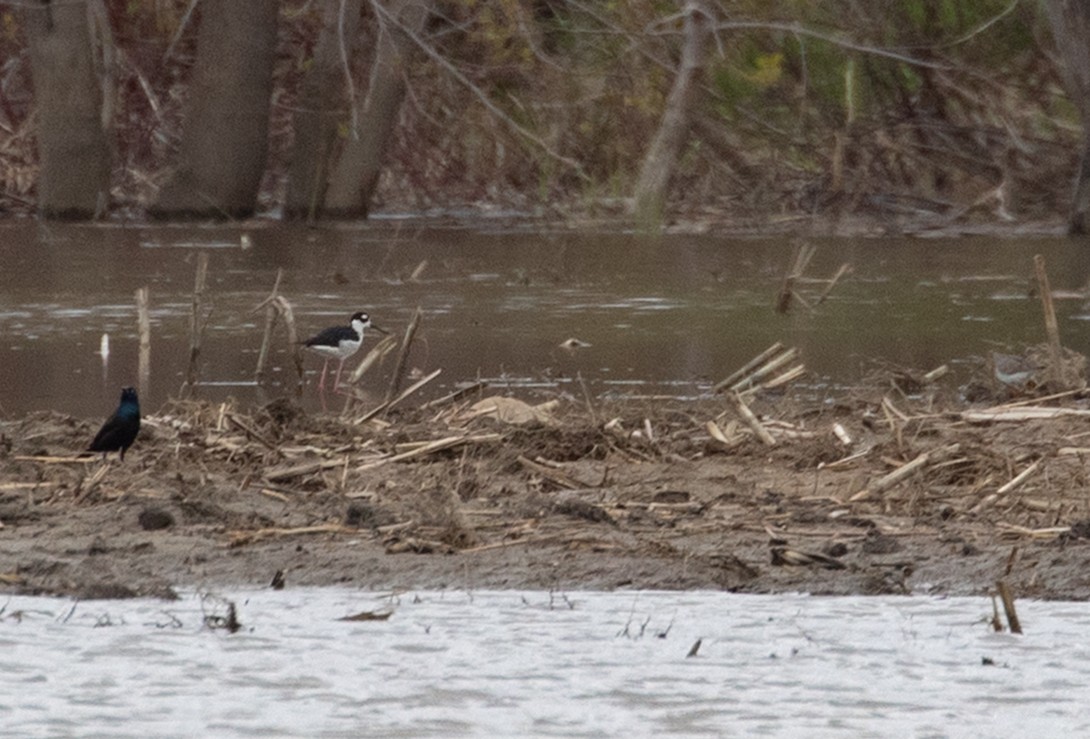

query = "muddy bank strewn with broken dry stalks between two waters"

[0,375,1090,599]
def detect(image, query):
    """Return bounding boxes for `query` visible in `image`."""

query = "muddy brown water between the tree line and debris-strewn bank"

[0,220,1090,416]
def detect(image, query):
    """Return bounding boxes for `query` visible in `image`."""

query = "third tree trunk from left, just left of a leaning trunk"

[283,0,362,220]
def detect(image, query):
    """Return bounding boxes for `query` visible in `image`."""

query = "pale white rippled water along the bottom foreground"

[0,589,1090,737]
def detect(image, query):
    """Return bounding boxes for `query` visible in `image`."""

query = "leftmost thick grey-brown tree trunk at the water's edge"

[24,1,110,219]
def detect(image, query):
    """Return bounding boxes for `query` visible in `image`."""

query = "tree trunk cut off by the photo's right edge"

[1044,0,1090,234]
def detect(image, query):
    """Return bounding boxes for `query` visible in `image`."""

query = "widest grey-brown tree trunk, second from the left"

[150,0,278,218]
